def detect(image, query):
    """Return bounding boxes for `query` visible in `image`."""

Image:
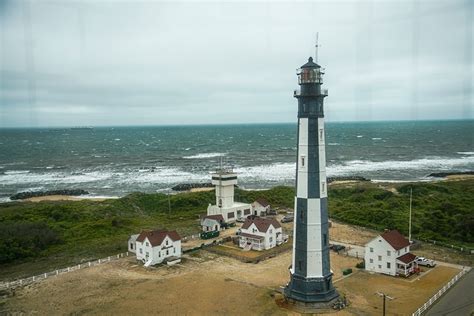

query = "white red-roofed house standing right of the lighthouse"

[365,230,418,276]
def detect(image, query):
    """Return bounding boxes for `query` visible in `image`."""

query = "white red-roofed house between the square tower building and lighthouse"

[239,217,283,250]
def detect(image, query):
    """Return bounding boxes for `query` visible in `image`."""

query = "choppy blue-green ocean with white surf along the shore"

[0,120,474,201]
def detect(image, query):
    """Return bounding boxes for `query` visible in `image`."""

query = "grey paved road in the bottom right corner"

[426,269,474,316]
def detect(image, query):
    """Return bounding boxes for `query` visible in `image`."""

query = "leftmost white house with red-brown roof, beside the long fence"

[135,230,181,267]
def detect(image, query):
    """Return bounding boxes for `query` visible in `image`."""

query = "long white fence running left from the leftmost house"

[0,251,129,290]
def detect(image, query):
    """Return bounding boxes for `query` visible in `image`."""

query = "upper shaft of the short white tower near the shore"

[212,168,237,208]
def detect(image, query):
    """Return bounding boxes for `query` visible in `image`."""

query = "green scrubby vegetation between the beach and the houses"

[0,179,474,279]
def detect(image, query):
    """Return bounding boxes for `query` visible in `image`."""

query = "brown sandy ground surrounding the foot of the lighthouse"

[0,251,458,315]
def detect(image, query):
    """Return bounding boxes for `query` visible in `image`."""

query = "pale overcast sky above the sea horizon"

[0,0,474,127]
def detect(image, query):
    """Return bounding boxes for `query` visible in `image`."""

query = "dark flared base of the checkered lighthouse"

[283,274,339,309]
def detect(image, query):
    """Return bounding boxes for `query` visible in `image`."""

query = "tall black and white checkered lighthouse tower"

[284,57,339,305]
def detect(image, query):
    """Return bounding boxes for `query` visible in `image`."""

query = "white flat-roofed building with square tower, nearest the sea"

[207,169,252,223]
